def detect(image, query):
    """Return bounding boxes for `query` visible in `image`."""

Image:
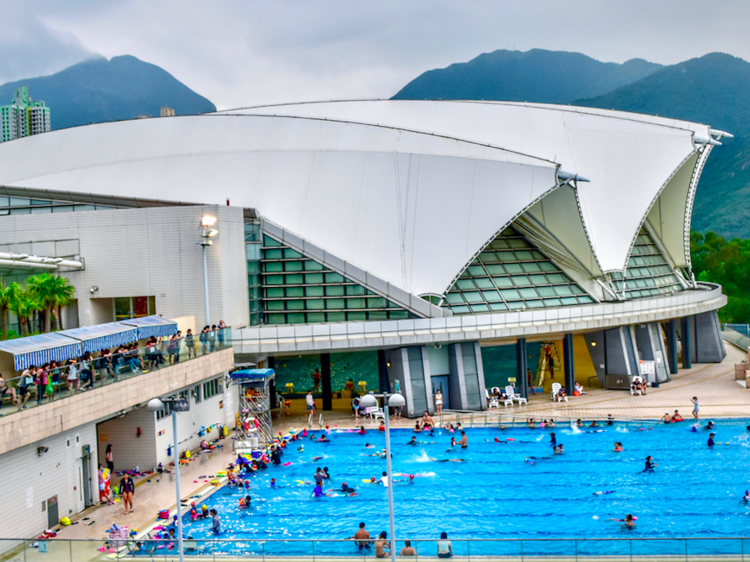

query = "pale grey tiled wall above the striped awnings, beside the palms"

[0,205,249,327]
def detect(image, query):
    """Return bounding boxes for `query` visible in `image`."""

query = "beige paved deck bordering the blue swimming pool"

[32,345,750,560]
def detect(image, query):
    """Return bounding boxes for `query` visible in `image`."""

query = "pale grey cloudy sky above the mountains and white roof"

[0,0,750,109]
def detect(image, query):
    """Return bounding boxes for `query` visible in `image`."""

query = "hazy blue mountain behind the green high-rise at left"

[0,55,216,129]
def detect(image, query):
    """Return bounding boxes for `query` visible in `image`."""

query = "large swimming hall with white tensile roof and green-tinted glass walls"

[0,101,726,415]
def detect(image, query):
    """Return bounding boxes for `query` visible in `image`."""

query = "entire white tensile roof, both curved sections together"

[0,101,709,295]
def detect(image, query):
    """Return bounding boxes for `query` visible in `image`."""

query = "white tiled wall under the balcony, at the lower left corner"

[0,423,99,538]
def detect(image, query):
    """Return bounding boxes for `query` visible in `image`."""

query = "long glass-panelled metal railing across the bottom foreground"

[0,537,750,562]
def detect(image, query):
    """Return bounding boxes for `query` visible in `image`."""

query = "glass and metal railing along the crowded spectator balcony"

[0,328,232,416]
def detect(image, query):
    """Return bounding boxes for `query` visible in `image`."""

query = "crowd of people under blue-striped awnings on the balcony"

[0,320,227,415]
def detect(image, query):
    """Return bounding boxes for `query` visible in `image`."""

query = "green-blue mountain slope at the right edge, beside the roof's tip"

[574,53,750,238]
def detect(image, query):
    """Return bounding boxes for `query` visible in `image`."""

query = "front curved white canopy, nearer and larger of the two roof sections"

[0,114,557,295]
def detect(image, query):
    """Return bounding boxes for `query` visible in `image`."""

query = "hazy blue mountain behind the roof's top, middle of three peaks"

[393,49,662,103]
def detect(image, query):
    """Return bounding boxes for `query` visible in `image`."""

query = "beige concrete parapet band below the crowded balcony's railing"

[0,348,234,458]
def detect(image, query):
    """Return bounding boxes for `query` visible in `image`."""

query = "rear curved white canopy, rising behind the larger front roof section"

[222,100,710,271]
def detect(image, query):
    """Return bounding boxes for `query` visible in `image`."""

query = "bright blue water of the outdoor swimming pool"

[173,420,750,555]
